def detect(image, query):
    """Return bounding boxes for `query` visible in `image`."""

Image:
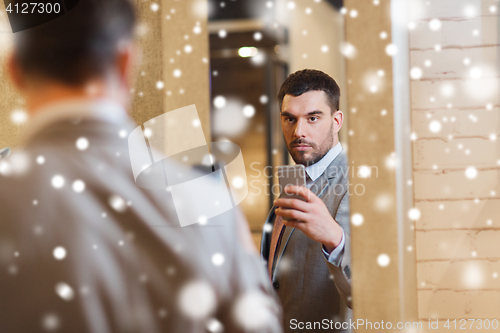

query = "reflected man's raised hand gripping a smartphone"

[274,185,342,253]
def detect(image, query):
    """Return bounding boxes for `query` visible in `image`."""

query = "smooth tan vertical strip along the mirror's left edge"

[160,0,211,143]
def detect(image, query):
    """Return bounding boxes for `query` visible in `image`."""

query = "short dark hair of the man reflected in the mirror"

[278,69,340,114]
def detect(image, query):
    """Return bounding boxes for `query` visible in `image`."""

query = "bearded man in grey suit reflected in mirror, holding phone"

[261,69,351,332]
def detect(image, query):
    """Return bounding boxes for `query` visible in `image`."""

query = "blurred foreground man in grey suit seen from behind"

[0,0,282,333]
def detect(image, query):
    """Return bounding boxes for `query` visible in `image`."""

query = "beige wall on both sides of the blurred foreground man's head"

[0,0,210,148]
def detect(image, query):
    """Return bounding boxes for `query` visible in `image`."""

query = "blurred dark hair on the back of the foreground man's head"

[14,0,136,86]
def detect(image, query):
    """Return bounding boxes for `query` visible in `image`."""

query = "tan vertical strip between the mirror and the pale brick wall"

[345,0,416,326]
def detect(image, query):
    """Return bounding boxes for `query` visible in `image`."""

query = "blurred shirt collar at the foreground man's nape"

[26,98,128,139]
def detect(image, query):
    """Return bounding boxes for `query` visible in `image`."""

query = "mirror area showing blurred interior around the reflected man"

[205,0,347,246]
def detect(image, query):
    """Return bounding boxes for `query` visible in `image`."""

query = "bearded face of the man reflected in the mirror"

[281,91,342,166]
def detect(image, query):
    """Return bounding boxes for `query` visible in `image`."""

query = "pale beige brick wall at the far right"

[410,0,500,326]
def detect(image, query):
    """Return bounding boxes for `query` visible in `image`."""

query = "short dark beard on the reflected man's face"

[287,123,334,167]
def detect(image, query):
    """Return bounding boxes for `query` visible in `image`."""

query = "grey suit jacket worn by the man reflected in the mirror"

[261,152,351,332]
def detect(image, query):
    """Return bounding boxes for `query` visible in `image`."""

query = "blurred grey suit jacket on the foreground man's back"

[0,116,282,333]
